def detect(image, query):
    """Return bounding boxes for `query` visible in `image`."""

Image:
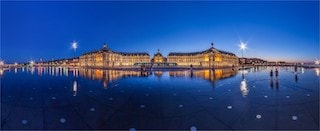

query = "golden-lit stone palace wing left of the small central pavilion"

[79,44,150,68]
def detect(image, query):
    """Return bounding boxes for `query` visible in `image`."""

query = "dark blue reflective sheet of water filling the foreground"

[0,67,320,131]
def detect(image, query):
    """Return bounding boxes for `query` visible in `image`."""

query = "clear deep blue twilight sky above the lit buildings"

[0,1,320,63]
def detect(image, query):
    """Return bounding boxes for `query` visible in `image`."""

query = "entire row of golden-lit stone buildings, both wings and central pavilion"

[38,43,239,68]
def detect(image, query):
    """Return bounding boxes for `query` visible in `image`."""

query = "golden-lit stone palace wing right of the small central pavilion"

[167,43,239,68]
